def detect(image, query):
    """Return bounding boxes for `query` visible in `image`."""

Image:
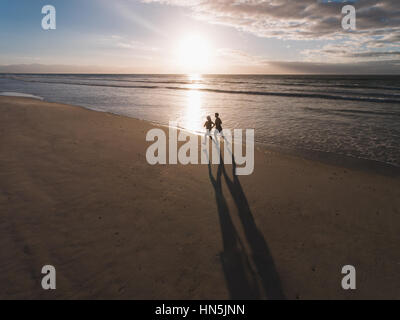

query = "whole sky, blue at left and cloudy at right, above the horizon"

[0,0,400,74]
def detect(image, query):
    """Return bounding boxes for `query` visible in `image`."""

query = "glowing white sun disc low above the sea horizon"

[177,35,211,73]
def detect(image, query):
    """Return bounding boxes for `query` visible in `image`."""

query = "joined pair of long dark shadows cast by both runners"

[208,145,285,300]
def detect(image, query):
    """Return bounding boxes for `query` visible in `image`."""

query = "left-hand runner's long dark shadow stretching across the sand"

[208,162,260,300]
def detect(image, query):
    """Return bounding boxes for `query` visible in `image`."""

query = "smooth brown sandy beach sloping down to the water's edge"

[0,97,400,299]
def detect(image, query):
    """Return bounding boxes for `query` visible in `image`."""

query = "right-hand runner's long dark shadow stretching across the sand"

[221,152,285,300]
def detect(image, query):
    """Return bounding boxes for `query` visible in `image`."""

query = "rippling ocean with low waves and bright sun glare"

[0,74,400,167]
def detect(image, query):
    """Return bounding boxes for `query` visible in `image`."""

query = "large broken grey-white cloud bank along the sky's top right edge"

[142,0,400,48]
